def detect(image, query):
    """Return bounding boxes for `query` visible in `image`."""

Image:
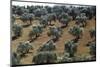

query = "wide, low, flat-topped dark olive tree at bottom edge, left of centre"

[32,52,57,64]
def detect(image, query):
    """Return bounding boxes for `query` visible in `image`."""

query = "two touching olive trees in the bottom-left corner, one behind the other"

[11,41,34,65]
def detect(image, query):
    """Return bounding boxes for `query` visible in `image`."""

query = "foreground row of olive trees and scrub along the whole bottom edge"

[12,37,96,65]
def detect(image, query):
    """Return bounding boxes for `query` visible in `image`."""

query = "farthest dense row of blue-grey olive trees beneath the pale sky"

[12,5,96,19]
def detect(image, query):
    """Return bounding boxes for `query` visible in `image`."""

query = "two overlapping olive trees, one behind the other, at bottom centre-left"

[32,40,57,64]
